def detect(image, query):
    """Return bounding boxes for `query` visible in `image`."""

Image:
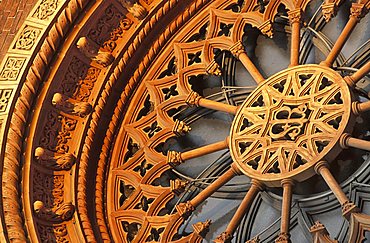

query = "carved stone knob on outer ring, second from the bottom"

[35,147,76,170]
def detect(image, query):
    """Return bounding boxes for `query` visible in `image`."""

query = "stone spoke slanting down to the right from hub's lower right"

[315,161,358,219]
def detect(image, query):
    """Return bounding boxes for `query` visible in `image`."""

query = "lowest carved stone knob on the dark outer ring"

[33,201,75,223]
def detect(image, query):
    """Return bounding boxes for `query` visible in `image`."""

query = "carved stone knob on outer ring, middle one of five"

[52,93,92,117]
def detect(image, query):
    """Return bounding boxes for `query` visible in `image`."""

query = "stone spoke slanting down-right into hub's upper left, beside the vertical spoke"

[230,41,265,84]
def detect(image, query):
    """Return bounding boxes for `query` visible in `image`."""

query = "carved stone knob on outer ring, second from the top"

[77,37,114,67]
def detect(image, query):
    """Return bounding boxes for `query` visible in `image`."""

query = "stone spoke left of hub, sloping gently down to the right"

[185,91,239,115]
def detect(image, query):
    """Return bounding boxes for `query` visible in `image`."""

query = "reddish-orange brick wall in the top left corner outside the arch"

[0,0,37,62]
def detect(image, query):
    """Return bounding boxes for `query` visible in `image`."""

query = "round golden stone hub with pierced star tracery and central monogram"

[230,65,351,186]
